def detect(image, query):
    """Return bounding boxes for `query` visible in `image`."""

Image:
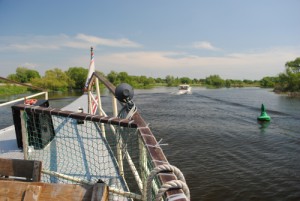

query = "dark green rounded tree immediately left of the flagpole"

[66,67,88,89]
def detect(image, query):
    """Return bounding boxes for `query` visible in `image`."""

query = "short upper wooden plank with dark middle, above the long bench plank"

[0,158,42,181]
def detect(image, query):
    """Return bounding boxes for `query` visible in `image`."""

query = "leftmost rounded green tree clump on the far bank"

[7,67,41,83]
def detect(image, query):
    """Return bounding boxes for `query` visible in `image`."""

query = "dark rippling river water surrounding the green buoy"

[0,87,300,201]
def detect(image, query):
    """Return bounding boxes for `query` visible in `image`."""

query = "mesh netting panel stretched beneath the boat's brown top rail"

[23,110,160,200]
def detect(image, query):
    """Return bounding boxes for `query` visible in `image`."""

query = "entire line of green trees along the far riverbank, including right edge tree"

[2,57,300,92]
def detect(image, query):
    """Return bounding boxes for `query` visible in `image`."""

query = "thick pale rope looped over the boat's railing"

[143,164,190,201]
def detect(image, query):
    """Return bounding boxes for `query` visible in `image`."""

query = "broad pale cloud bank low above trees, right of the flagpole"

[88,48,300,79]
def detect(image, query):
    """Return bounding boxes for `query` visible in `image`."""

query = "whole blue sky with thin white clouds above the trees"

[0,0,300,80]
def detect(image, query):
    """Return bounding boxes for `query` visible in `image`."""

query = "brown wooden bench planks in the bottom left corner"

[0,158,109,201]
